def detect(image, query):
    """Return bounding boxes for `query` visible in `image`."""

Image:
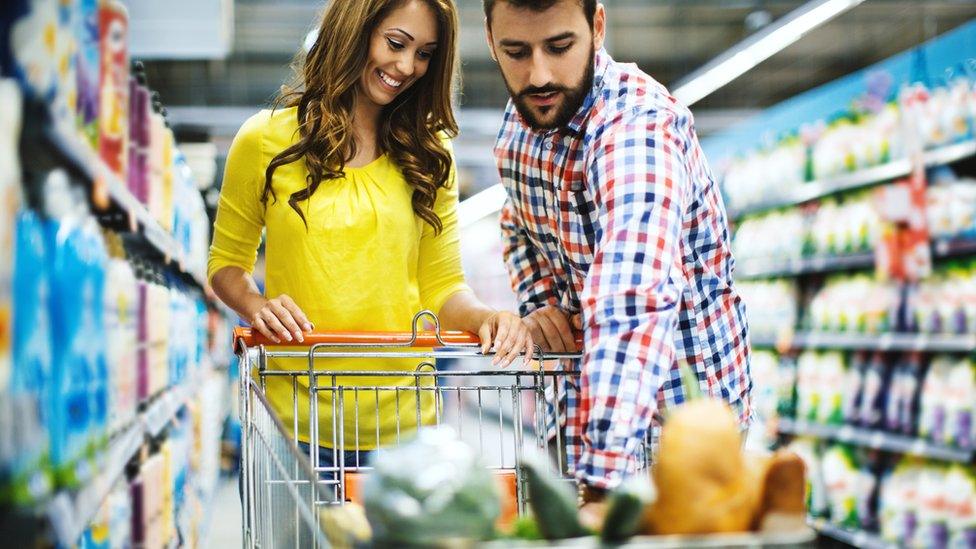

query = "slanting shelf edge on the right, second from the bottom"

[778,418,973,463]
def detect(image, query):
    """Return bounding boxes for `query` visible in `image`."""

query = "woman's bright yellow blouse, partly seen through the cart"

[208,108,467,450]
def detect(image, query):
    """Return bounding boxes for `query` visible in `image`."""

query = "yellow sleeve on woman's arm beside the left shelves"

[207,112,269,280]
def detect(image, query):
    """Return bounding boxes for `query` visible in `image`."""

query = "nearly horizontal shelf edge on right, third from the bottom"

[751,332,976,353]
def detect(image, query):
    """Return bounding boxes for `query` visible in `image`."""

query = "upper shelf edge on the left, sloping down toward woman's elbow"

[46,121,206,288]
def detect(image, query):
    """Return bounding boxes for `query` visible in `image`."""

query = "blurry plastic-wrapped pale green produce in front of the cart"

[363,427,501,546]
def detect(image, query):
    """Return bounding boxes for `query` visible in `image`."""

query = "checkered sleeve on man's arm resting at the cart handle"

[501,198,559,316]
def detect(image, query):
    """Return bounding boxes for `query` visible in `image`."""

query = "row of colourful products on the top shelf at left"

[0,0,209,273]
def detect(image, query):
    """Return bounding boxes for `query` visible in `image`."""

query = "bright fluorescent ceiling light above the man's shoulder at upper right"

[672,0,864,105]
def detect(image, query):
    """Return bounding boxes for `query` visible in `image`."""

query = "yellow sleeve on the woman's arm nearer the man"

[417,140,469,313]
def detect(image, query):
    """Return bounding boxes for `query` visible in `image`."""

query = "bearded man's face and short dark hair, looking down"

[488,0,606,130]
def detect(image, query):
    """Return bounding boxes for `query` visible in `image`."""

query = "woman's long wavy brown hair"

[261,0,458,233]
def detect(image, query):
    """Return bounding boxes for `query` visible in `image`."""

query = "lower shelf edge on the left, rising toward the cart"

[46,380,198,547]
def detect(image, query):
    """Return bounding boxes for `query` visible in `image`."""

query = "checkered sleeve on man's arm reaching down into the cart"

[576,110,692,488]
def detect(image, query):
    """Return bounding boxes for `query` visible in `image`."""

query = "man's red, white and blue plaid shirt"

[495,50,752,488]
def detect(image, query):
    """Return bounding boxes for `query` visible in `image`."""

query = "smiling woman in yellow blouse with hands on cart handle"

[208,0,532,466]
